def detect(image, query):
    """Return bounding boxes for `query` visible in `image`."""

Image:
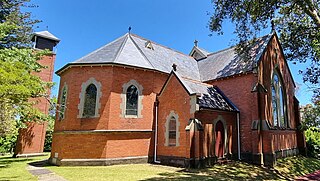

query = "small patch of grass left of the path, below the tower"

[0,155,48,180]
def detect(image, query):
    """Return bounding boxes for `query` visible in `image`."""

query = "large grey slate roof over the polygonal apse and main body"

[68,33,200,80]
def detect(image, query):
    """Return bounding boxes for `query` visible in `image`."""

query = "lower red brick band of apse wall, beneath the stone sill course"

[52,133,152,159]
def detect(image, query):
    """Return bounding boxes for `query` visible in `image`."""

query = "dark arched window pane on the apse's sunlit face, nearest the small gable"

[126,85,139,115]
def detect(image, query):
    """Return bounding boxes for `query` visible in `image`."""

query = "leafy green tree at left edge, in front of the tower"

[0,0,52,137]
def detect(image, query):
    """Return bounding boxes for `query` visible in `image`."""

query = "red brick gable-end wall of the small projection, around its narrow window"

[157,76,194,158]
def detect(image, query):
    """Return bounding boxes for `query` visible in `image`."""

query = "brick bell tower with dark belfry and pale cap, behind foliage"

[14,31,60,157]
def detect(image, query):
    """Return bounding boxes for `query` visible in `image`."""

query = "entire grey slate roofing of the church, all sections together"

[56,33,273,111]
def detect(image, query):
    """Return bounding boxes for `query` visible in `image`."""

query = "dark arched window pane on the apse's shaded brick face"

[82,84,97,117]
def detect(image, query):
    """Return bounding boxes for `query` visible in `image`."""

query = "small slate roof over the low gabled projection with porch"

[159,71,239,112]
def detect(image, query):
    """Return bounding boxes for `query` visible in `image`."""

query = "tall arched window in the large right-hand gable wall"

[271,72,287,127]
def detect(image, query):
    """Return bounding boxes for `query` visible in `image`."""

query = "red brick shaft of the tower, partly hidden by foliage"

[15,54,56,154]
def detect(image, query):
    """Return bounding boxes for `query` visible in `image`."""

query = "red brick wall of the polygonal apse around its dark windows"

[52,66,168,159]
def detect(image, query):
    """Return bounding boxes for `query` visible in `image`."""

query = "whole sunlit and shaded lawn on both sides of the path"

[0,156,320,181]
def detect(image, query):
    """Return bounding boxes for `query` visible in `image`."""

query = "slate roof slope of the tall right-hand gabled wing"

[198,34,274,82]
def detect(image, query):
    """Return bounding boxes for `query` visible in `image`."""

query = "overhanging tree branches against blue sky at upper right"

[209,0,320,97]
